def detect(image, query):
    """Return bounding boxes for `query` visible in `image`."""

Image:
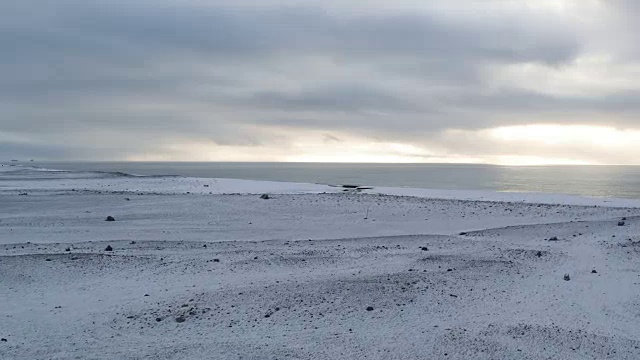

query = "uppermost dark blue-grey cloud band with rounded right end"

[0,2,578,64]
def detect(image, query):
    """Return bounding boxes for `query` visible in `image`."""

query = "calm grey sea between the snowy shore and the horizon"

[11,162,640,199]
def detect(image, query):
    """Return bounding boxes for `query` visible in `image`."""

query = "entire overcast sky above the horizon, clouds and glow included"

[0,0,640,165]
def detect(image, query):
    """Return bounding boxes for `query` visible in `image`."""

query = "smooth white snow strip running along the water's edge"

[0,165,640,208]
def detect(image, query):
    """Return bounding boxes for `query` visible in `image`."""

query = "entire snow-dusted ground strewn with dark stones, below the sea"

[0,166,640,359]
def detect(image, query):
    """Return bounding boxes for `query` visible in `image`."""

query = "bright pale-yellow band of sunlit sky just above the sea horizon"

[128,124,640,166]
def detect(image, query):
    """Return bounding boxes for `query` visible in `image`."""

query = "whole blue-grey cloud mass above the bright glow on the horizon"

[0,0,639,158]
